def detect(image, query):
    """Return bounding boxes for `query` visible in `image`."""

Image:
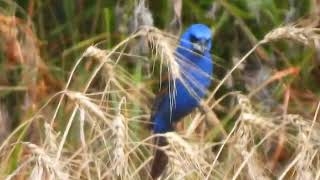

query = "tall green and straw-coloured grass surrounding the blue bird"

[0,0,320,179]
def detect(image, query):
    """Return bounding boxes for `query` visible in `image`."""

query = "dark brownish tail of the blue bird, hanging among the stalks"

[150,136,169,179]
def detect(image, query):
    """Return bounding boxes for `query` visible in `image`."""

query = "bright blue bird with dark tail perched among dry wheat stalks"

[151,24,213,179]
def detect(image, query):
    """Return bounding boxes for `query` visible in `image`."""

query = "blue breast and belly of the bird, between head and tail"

[153,48,213,133]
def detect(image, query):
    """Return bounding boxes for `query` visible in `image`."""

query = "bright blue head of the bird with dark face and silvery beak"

[180,24,212,55]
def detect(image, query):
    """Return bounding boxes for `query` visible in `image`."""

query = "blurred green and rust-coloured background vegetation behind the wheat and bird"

[0,0,320,179]
